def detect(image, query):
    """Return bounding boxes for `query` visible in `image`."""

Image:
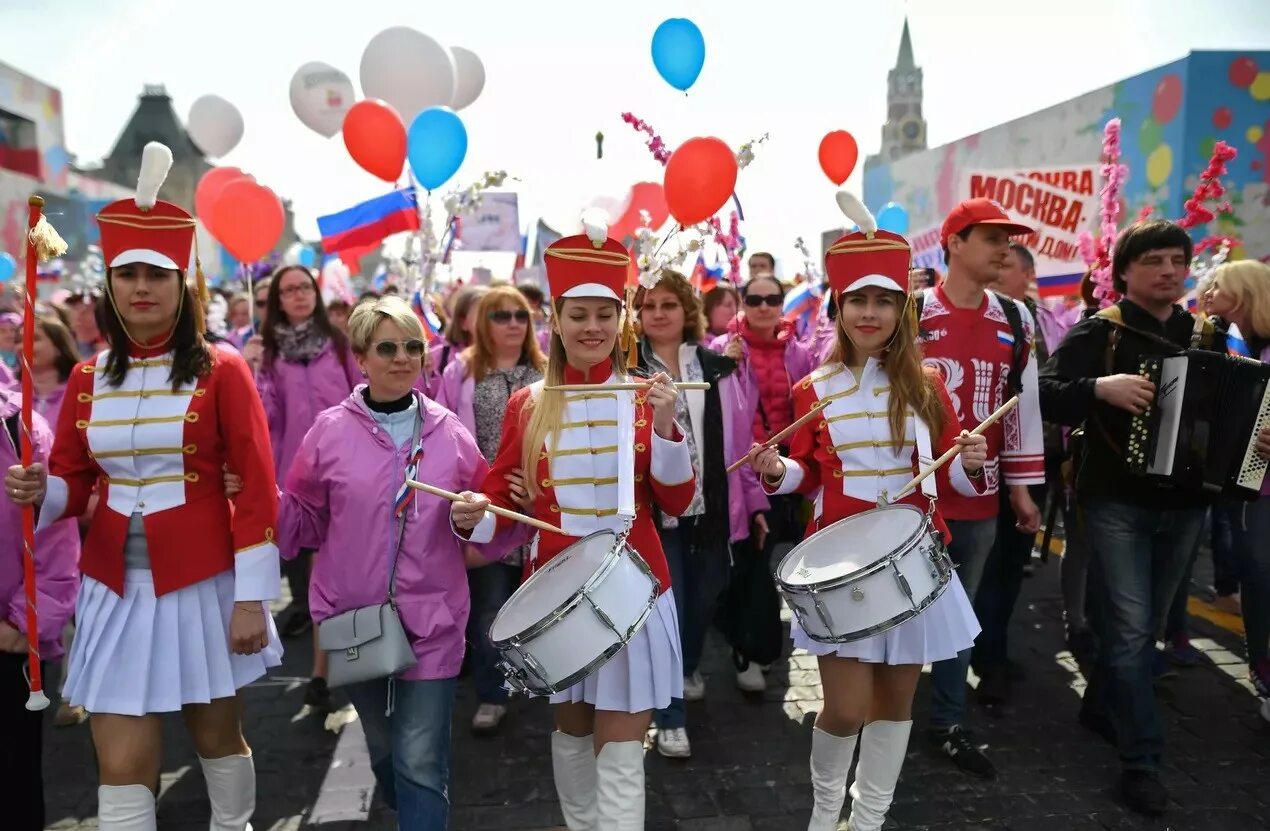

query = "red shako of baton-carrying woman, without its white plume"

[97,198,194,271]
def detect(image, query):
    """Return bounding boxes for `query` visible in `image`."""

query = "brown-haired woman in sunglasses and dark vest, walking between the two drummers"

[636,269,768,759]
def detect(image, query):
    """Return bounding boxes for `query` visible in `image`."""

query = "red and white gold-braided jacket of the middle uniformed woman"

[470,362,696,592]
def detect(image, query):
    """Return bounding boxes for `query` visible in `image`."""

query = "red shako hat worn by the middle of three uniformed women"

[542,213,631,302]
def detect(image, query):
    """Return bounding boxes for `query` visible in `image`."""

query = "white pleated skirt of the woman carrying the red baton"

[65,569,282,715]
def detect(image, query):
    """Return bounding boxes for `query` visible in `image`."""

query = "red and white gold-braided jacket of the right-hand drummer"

[765,358,983,539]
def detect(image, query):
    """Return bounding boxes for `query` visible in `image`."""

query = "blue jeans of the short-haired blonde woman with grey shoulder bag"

[345,679,456,831]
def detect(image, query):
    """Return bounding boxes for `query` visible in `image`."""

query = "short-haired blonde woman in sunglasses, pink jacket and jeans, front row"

[278,297,528,831]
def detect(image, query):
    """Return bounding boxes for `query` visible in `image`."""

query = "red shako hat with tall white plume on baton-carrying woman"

[97,141,194,272]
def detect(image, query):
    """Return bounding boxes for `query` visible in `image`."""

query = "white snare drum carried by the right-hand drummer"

[776,504,953,643]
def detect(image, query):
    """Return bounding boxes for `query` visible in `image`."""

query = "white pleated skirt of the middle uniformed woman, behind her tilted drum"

[551,588,683,713]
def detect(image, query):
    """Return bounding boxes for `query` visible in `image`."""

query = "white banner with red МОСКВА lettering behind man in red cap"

[955,164,1099,297]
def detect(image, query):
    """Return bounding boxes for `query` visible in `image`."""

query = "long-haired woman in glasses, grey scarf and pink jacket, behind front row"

[243,266,361,710]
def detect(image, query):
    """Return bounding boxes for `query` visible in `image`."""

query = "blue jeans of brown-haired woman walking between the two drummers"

[654,517,728,729]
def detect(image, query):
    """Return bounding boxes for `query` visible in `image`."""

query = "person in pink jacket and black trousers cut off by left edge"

[0,389,79,831]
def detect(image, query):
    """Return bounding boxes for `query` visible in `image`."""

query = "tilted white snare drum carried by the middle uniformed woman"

[489,531,660,695]
